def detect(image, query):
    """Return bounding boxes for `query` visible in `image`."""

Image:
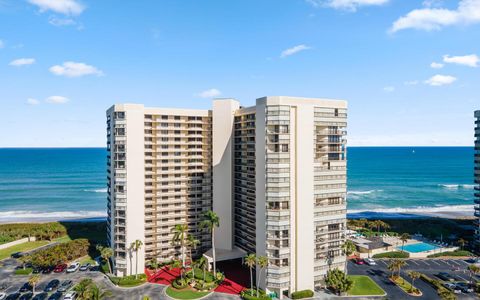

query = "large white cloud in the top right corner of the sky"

[390,0,480,33]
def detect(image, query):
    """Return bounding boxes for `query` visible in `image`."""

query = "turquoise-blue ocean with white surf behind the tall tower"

[0,147,474,222]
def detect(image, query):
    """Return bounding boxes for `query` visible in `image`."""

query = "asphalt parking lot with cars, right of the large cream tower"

[348,259,477,299]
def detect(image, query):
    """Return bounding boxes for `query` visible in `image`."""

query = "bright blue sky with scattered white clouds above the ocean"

[0,0,480,147]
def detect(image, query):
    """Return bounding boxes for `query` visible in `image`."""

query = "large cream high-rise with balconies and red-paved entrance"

[107,97,347,295]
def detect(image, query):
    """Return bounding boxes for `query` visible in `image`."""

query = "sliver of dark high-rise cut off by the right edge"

[474,110,480,246]
